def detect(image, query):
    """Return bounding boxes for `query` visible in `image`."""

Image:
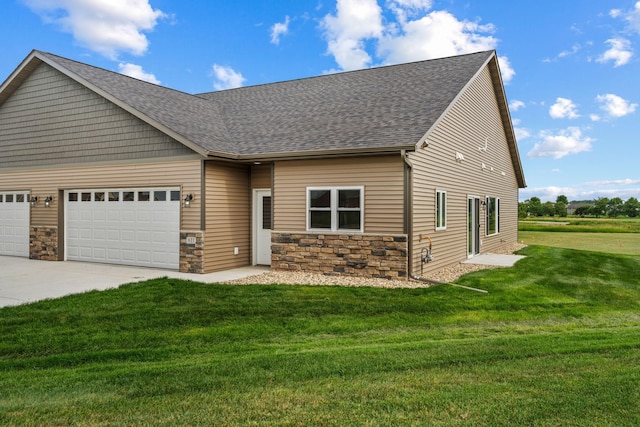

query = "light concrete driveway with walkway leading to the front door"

[0,256,269,307]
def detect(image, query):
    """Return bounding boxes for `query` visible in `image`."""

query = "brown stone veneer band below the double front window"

[271,232,408,279]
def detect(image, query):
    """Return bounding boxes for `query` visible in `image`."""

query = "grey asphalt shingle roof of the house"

[38,51,494,158]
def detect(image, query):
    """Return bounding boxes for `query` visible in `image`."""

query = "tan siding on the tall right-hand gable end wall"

[409,68,518,274]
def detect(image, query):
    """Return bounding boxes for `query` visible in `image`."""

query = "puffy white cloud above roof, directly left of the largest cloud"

[321,0,383,70]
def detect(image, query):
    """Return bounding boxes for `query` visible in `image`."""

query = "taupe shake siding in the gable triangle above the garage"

[0,63,193,168]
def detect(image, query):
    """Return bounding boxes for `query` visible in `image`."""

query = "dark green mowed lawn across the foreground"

[0,246,640,426]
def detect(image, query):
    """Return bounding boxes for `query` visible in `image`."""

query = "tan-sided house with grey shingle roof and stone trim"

[0,51,525,278]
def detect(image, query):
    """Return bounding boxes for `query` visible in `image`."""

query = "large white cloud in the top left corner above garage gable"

[24,0,166,59]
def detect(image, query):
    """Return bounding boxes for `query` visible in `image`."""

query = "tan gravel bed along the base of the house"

[223,243,526,288]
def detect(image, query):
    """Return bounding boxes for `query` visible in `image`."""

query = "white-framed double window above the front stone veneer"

[307,187,364,232]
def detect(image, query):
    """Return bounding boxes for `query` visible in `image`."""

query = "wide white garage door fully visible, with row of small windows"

[65,188,180,269]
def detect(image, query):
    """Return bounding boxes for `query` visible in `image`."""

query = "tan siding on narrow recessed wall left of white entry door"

[204,161,251,272]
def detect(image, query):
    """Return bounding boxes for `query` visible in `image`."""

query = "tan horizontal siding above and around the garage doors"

[0,160,202,230]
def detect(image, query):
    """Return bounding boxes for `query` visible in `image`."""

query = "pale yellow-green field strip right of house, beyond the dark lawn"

[518,231,640,255]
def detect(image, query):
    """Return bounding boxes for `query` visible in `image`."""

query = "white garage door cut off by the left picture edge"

[0,191,29,257]
